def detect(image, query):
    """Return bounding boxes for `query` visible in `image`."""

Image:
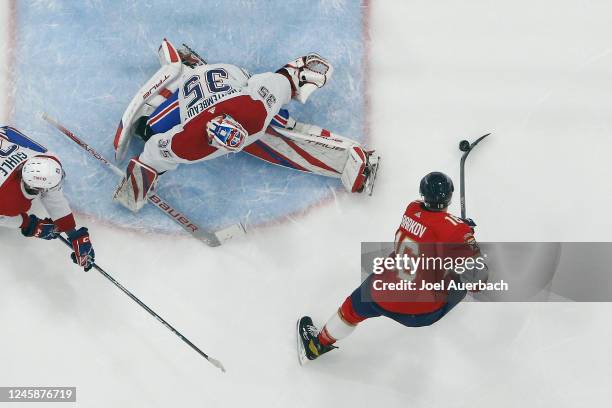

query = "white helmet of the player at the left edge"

[21,156,65,194]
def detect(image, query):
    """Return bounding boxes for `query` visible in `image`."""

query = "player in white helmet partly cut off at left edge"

[0,126,95,271]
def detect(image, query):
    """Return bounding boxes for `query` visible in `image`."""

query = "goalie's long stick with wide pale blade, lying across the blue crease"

[42,113,246,247]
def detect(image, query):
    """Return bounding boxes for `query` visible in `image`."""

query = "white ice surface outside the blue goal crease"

[0,0,612,408]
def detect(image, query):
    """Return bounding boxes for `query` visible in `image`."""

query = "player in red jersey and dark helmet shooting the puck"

[298,172,487,363]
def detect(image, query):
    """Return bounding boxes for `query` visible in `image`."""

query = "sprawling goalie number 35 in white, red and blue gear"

[114,40,378,211]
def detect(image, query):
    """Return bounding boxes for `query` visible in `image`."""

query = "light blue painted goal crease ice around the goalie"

[12,0,364,232]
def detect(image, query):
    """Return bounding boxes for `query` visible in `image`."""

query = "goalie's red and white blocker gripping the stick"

[113,158,158,212]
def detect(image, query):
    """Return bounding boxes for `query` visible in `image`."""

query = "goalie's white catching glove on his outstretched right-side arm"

[276,53,334,103]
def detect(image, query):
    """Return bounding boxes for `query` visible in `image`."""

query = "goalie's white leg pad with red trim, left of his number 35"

[113,40,183,162]
